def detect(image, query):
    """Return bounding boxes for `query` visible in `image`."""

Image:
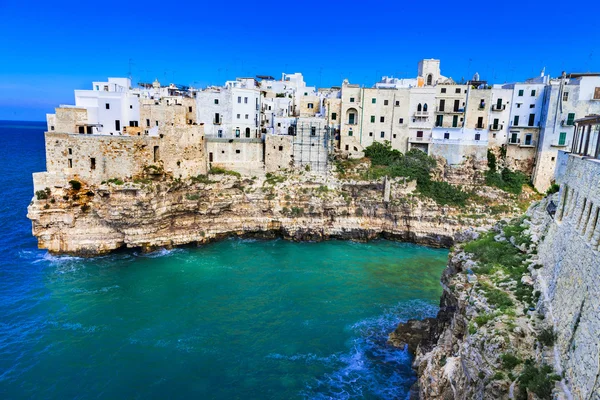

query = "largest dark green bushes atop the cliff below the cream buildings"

[365,141,469,206]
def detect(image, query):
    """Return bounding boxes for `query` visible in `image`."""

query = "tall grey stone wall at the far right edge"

[539,155,600,399]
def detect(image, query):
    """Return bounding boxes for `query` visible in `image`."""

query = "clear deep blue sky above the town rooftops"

[0,0,600,120]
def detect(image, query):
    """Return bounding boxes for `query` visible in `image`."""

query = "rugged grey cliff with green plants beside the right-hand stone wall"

[389,203,570,399]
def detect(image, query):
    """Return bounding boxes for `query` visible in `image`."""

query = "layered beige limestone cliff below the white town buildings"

[28,170,510,255]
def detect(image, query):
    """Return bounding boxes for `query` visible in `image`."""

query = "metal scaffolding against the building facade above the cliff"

[290,119,333,175]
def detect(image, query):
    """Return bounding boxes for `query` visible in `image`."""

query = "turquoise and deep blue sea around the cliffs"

[0,121,448,399]
